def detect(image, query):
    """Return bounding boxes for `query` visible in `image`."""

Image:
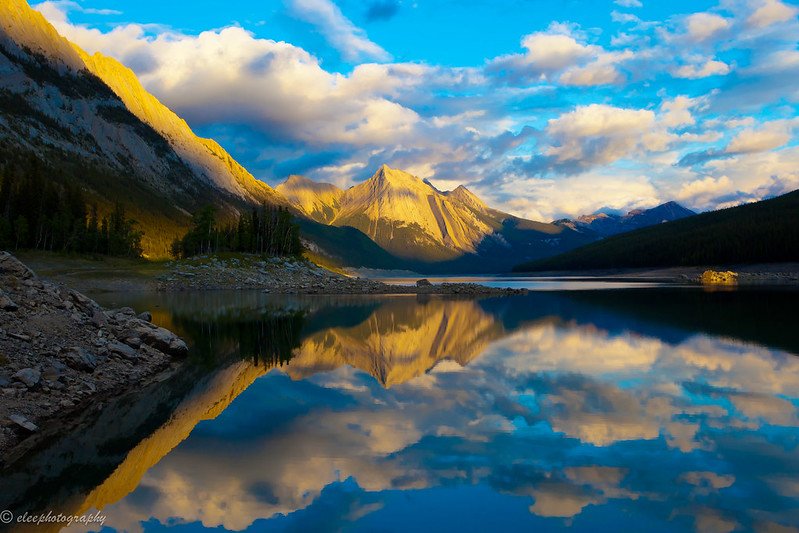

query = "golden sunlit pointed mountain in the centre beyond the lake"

[277,165,594,272]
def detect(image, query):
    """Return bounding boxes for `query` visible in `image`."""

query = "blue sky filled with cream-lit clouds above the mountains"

[38,0,799,220]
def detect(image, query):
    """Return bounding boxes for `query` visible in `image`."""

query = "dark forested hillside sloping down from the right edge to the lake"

[514,191,799,272]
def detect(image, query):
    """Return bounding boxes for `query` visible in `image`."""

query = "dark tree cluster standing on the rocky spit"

[172,204,302,258]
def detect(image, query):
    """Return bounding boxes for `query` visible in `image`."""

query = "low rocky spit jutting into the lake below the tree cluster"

[158,256,527,296]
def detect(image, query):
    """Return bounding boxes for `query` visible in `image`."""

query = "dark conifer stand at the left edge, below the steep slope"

[0,158,143,257]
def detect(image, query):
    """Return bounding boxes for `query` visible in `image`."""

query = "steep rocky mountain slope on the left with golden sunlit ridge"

[0,0,286,256]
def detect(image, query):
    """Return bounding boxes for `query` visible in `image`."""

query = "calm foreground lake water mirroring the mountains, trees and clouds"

[0,286,799,532]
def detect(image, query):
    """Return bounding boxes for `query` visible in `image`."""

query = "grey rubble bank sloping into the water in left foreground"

[0,252,188,465]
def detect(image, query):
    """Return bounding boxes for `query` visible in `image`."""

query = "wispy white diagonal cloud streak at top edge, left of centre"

[290,0,391,61]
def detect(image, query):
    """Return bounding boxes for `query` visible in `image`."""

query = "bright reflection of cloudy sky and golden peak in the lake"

[79,296,799,531]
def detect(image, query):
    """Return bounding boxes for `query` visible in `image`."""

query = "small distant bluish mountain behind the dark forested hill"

[554,202,696,237]
